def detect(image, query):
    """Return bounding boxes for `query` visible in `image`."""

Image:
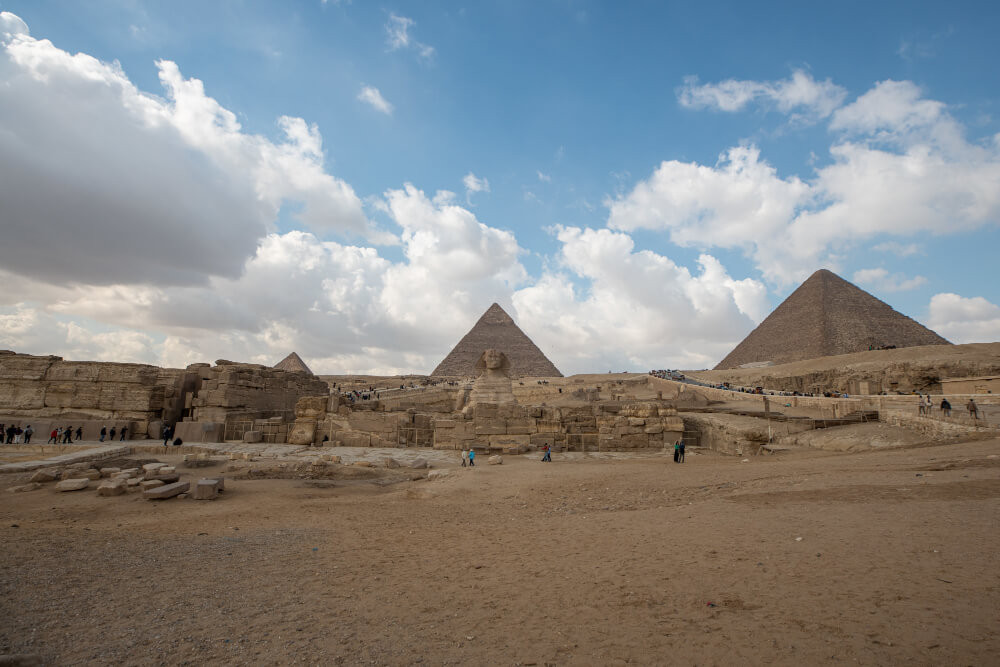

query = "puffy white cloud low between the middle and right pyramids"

[513,227,769,373]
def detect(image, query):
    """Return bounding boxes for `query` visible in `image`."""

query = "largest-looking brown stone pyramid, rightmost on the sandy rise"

[715,269,950,370]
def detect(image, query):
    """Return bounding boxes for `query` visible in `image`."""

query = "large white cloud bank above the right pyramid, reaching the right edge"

[608,77,1000,285]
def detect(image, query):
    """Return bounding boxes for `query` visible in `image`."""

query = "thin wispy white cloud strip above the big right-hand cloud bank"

[677,70,847,120]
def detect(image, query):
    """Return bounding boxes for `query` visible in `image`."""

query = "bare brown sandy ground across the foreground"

[0,440,1000,665]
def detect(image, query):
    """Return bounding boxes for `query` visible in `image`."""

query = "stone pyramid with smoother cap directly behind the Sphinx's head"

[431,303,562,377]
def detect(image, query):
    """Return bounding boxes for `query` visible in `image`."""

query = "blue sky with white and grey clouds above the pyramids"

[0,0,1000,374]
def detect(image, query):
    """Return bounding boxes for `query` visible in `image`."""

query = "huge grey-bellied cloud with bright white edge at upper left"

[0,14,382,284]
